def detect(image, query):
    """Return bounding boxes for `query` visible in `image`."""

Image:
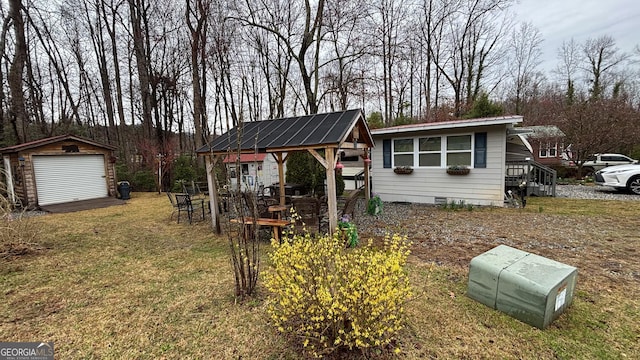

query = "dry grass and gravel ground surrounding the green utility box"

[359,198,640,359]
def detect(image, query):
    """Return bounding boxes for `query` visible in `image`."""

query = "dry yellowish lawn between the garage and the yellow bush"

[0,194,286,359]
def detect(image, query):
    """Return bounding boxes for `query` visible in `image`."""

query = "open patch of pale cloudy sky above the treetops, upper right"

[512,0,640,72]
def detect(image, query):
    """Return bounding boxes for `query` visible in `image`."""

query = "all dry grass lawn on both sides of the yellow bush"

[0,193,640,359]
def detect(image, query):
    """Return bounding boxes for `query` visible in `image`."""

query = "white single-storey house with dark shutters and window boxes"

[371,116,523,206]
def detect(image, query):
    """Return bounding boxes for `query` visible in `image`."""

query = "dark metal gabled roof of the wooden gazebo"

[196,109,374,153]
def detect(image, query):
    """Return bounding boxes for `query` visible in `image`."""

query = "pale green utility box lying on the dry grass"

[467,245,578,329]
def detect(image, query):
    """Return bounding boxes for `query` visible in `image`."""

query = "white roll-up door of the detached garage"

[33,155,108,206]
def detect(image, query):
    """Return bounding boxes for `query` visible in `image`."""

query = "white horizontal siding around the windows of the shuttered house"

[372,126,506,206]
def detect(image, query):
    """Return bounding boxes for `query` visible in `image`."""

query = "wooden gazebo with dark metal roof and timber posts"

[197,109,374,232]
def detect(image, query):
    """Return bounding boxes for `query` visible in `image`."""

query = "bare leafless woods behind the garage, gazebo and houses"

[0,0,640,186]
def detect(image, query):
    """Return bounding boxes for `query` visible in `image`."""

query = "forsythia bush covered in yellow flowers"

[266,232,411,357]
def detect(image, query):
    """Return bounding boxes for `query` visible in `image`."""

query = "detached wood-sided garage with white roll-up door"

[0,135,116,208]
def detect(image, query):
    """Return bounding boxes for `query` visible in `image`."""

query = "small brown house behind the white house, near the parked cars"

[518,125,572,166]
